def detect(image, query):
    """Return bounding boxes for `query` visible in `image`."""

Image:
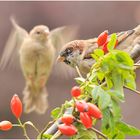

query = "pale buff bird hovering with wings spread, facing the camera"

[0,19,76,113]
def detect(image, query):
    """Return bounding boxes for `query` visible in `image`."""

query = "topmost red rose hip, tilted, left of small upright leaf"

[97,30,108,47]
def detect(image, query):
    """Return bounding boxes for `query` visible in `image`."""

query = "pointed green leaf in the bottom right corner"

[116,122,140,136]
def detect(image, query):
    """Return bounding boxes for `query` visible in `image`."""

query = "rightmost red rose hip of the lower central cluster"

[87,103,102,119]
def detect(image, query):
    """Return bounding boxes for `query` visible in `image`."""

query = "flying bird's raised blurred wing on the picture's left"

[0,18,28,69]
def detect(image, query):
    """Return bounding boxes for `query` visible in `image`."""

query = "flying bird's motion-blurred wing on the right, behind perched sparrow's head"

[49,26,78,77]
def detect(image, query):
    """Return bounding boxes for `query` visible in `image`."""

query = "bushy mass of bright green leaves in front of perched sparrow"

[74,41,140,139]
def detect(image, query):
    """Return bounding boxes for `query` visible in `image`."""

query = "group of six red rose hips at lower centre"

[58,86,102,136]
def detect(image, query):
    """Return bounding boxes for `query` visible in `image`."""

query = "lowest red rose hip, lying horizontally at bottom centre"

[58,124,77,136]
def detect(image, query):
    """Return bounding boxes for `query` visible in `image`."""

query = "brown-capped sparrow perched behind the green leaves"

[57,25,140,74]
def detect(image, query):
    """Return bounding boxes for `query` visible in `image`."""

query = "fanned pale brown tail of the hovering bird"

[23,85,48,114]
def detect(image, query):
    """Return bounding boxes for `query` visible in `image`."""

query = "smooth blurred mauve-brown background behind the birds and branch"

[0,1,140,139]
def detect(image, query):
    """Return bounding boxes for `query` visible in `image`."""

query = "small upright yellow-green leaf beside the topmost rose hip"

[107,33,117,51]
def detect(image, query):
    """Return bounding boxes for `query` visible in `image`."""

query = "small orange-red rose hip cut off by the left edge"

[0,121,12,131]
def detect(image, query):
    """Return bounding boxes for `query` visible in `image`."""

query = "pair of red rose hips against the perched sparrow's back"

[97,30,118,53]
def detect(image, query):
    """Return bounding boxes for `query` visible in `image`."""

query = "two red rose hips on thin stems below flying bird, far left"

[0,94,22,131]
